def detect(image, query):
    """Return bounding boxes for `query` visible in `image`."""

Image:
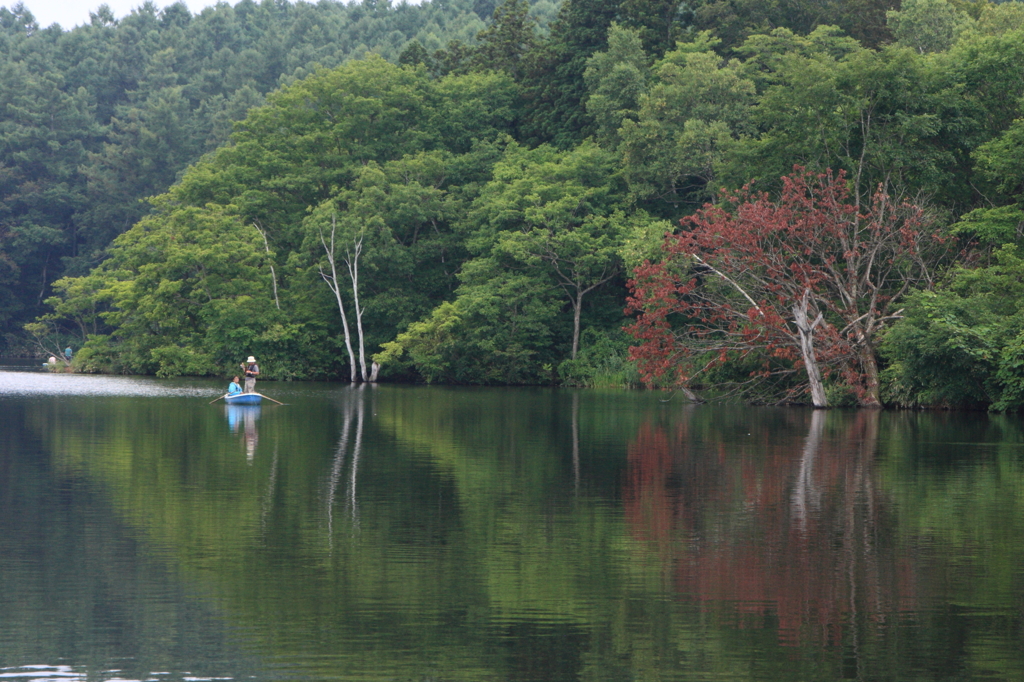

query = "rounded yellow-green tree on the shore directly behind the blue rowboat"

[54,200,288,376]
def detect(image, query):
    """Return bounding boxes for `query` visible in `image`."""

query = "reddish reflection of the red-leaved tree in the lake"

[624,412,913,645]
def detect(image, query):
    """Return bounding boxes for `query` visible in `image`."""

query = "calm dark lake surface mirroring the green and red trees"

[0,371,1024,681]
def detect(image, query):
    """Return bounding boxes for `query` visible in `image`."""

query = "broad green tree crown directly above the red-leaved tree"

[719,28,975,210]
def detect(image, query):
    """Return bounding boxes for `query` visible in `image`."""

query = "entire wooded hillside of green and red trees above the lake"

[6,0,1024,411]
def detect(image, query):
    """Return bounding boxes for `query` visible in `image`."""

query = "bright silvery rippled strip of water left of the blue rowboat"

[0,372,214,397]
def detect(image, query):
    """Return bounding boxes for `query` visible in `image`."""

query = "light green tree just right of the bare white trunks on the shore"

[376,143,630,383]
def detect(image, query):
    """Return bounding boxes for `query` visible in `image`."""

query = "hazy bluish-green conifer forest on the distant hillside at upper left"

[0,0,556,342]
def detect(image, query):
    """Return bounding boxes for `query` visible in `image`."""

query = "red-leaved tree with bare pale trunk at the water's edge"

[627,168,942,407]
